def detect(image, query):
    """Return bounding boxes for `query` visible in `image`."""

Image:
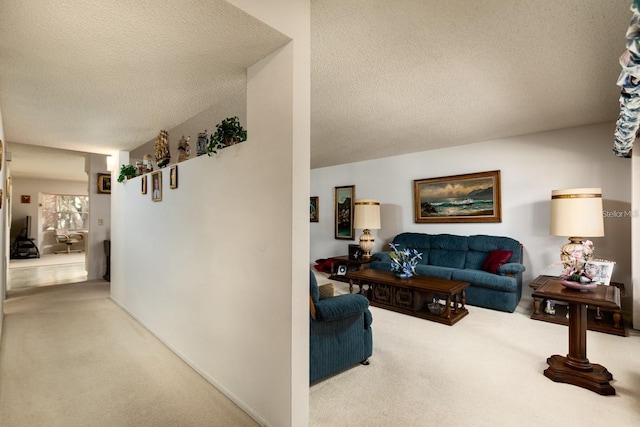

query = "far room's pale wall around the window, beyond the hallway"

[11,177,89,254]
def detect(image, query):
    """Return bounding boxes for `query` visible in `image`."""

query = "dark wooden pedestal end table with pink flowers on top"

[533,280,620,395]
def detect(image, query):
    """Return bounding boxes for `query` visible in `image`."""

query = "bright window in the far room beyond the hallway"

[42,194,89,231]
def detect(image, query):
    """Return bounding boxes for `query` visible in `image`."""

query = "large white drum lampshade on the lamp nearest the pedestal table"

[551,188,604,237]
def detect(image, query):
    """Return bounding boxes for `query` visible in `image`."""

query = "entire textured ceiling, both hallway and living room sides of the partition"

[0,0,632,177]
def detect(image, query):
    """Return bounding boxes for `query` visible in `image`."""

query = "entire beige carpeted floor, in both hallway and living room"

[0,280,640,427]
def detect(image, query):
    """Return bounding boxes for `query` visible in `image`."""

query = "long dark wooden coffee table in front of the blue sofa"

[346,269,469,325]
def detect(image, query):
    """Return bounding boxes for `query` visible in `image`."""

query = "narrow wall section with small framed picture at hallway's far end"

[85,154,110,280]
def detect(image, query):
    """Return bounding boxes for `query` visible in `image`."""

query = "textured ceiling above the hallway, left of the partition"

[0,0,289,153]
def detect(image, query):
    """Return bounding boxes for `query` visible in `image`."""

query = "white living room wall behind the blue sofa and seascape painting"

[311,123,639,318]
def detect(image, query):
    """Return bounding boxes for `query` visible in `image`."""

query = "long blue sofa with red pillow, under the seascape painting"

[370,233,525,312]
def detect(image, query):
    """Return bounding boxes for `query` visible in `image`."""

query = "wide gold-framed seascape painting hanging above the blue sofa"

[413,170,502,223]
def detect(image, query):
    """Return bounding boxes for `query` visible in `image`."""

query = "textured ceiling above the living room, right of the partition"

[311,0,632,167]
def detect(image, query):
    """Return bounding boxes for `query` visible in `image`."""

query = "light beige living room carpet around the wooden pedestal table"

[310,277,640,427]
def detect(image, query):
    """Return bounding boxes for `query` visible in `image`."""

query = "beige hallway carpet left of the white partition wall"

[0,281,256,427]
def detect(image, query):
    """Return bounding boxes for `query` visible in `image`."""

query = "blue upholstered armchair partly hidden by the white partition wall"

[309,271,373,383]
